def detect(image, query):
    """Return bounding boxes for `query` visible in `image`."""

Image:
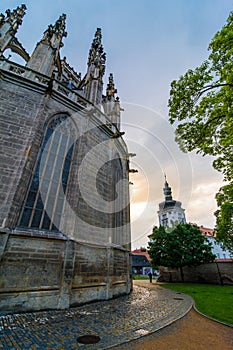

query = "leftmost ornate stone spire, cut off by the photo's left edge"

[0,4,26,56]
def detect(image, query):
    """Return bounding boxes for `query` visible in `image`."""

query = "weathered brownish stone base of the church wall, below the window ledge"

[0,232,131,315]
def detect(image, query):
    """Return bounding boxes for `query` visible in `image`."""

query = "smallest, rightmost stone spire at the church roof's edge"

[103,73,121,129]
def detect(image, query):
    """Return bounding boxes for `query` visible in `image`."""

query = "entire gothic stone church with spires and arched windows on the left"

[0,5,132,314]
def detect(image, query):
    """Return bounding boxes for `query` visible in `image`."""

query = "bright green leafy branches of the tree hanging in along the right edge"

[168,12,233,250]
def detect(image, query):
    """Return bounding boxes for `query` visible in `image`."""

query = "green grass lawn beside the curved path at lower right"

[160,283,233,325]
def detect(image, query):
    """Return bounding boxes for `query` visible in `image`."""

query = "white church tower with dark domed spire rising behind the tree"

[158,176,186,228]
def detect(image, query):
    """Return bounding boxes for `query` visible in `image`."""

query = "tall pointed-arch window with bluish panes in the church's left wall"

[19,115,75,231]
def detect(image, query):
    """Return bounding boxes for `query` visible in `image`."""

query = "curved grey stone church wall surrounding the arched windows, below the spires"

[0,60,132,313]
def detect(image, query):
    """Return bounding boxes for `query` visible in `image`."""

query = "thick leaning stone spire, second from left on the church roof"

[27,14,67,76]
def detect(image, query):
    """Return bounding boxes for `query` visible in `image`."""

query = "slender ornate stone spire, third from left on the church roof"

[84,28,106,105]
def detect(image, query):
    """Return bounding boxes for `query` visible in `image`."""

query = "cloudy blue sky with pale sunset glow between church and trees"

[0,0,233,249]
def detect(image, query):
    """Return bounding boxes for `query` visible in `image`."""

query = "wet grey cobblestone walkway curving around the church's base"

[0,280,192,350]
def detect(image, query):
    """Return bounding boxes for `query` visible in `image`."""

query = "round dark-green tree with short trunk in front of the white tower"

[149,224,215,281]
